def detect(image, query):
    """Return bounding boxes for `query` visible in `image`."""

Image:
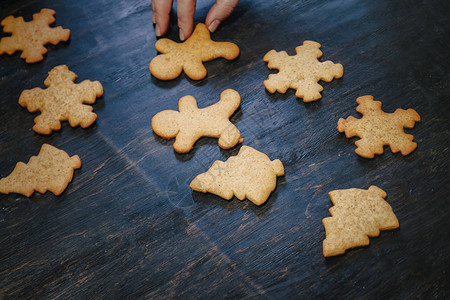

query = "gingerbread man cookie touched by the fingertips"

[149,23,239,80]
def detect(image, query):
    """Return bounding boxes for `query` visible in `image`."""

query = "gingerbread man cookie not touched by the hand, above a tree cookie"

[152,89,242,153]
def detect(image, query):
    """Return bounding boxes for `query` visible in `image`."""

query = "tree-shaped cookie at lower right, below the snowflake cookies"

[322,186,399,257]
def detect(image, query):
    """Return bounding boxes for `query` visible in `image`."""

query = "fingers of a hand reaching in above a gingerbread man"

[152,0,239,41]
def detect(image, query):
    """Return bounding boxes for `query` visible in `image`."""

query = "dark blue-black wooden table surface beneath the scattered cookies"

[0,0,450,299]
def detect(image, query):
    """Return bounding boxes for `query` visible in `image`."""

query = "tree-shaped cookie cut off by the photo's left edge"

[0,144,81,197]
